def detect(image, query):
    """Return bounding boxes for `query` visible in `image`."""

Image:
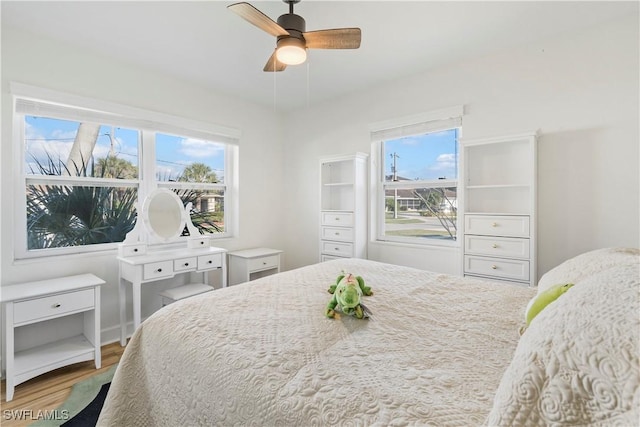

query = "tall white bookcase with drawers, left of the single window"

[320,153,367,261]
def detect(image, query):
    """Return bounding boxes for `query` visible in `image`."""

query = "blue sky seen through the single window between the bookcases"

[384,129,458,180]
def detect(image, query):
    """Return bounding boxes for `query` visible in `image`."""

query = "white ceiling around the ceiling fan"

[1,0,638,111]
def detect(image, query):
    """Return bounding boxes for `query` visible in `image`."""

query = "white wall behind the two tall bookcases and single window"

[284,16,640,275]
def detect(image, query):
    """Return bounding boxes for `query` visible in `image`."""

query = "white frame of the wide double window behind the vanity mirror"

[10,82,240,260]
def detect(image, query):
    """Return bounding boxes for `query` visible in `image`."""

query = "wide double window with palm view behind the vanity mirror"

[12,85,237,258]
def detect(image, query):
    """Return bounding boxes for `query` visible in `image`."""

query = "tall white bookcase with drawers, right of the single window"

[460,132,537,286]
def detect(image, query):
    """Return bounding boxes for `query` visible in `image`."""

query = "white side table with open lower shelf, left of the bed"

[2,274,105,402]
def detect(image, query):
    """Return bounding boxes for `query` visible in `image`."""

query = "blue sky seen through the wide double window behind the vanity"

[25,116,224,179]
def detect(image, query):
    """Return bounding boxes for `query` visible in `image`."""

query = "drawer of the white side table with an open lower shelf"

[13,288,95,325]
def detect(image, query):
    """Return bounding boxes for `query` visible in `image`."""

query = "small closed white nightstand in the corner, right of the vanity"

[229,248,282,285]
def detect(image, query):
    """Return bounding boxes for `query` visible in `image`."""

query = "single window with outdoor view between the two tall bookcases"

[372,107,462,244]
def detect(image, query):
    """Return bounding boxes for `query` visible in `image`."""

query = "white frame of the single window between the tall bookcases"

[370,105,464,247]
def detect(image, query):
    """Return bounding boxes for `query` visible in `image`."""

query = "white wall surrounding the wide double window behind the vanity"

[0,26,284,344]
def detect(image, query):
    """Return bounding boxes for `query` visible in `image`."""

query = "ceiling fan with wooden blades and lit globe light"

[227,0,361,71]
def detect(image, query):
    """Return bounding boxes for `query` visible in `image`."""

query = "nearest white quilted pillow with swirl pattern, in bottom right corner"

[485,263,640,426]
